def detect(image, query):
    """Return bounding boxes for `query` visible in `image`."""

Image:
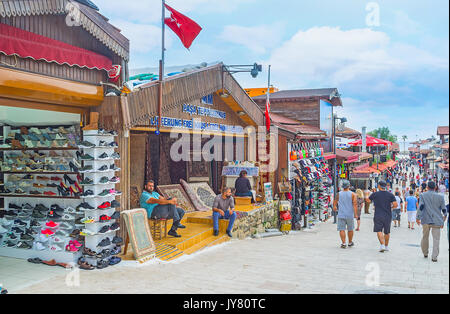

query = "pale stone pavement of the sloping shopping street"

[11,204,449,294]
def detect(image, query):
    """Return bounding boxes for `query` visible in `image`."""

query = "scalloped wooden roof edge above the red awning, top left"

[0,0,130,61]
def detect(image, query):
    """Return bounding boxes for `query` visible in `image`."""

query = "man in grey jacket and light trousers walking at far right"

[417,181,447,262]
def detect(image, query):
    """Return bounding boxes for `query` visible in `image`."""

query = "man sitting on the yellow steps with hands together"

[213,188,236,238]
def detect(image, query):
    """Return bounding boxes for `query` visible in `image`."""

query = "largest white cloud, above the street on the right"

[268,27,448,92]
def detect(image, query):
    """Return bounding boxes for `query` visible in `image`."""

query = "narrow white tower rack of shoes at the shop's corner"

[80,130,122,268]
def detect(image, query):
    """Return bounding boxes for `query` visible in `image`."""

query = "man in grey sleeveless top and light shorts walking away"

[333,180,358,249]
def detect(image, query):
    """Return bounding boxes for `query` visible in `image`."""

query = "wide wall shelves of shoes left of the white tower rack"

[0,126,83,263]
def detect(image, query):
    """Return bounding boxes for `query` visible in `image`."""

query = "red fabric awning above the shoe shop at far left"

[0,23,112,71]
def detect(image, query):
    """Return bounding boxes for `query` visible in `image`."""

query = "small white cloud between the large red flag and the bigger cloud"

[219,23,283,54]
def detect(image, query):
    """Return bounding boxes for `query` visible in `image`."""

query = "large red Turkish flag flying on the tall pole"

[164,4,202,49]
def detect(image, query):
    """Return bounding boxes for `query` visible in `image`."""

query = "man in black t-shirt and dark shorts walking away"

[369,181,398,253]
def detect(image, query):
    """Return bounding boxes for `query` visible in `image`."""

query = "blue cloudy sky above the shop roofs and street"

[94,0,449,140]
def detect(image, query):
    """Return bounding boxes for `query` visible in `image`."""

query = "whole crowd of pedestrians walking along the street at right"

[333,159,450,262]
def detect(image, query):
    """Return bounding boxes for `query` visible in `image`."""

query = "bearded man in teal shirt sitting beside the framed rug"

[140,180,186,238]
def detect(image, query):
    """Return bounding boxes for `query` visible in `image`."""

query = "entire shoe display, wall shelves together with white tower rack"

[0,126,122,269]
